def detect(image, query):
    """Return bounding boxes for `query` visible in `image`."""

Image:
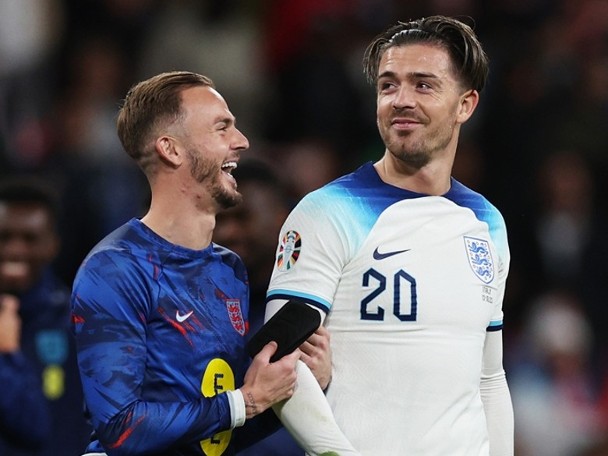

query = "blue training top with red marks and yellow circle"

[72,219,249,455]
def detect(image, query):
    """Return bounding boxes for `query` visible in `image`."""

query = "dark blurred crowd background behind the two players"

[0,0,608,456]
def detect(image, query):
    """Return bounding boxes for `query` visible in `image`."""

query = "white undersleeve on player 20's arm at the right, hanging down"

[480,331,515,456]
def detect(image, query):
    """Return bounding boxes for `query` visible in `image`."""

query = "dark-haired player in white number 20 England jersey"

[266,16,514,456]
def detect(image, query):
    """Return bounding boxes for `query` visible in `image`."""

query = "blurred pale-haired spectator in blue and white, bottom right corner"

[509,290,606,456]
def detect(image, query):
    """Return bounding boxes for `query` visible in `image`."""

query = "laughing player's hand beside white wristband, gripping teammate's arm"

[240,342,301,419]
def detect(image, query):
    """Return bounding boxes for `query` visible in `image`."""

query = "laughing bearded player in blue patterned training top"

[72,72,356,456]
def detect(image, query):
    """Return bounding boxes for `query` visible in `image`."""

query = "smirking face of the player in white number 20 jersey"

[376,44,478,169]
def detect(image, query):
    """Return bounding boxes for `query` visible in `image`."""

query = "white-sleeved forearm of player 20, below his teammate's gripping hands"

[273,362,359,456]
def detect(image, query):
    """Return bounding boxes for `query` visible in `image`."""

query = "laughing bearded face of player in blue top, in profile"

[176,87,249,208]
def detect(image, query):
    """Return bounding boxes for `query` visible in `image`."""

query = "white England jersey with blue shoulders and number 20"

[268,163,509,456]
